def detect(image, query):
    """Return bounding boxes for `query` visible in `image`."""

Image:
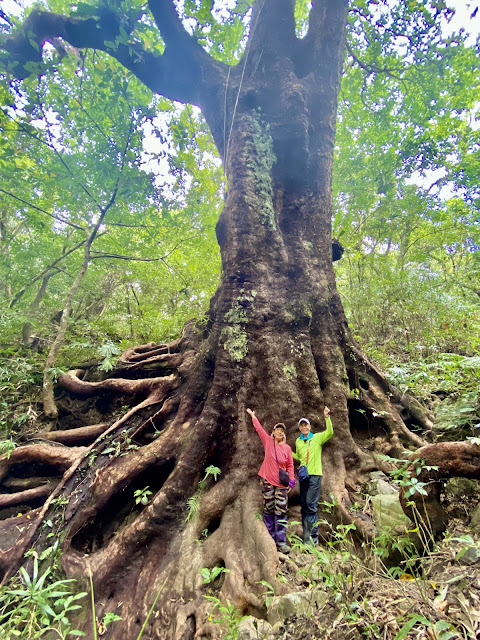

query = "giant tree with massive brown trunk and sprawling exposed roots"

[0,0,480,639]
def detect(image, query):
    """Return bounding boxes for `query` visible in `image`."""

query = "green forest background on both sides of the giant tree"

[0,0,480,640]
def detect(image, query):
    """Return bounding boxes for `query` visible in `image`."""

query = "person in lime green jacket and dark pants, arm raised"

[293,407,333,544]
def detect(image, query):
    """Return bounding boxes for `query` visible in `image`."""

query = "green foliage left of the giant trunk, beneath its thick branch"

[0,40,223,422]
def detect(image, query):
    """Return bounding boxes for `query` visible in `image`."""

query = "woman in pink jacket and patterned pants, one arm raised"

[247,409,295,553]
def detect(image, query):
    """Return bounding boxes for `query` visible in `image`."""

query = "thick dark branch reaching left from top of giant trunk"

[0,7,226,105]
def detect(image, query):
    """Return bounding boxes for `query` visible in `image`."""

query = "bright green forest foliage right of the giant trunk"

[333,2,480,362]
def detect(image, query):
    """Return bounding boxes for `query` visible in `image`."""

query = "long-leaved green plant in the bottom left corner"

[0,556,87,640]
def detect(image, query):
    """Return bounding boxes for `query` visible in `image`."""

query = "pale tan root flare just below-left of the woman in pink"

[161,480,276,638]
